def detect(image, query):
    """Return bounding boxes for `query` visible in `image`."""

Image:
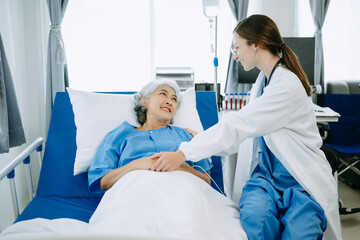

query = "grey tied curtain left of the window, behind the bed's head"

[45,0,69,135]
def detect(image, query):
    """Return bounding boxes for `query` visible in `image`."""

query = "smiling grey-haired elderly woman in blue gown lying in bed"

[88,80,212,192]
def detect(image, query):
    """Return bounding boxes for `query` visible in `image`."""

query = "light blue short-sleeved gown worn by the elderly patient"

[88,121,213,192]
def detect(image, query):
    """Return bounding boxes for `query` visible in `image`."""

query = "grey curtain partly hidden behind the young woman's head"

[225,0,249,93]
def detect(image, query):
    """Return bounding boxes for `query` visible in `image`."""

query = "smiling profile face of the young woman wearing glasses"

[233,32,256,71]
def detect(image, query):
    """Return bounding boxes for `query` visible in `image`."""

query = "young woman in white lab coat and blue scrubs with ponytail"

[152,15,341,239]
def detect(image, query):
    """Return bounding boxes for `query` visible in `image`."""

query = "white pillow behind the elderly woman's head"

[67,88,203,175]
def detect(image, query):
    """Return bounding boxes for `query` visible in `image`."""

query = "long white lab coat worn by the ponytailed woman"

[179,66,341,239]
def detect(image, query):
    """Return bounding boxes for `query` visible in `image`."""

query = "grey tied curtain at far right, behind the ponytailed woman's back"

[309,0,330,89]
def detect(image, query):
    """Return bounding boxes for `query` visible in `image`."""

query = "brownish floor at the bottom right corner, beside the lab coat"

[339,181,360,240]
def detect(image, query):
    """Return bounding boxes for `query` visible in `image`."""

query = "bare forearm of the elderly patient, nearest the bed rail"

[100,157,157,190]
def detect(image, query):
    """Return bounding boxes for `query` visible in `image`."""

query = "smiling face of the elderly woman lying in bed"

[146,85,177,124]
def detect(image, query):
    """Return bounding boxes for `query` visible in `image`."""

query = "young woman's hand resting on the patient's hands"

[151,150,186,172]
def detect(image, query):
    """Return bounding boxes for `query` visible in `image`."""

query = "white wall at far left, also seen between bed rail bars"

[0,0,49,230]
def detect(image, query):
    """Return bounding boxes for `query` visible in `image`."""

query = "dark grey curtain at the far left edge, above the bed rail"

[0,34,26,153]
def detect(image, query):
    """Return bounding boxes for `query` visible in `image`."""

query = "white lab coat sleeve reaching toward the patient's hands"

[179,80,294,162]
